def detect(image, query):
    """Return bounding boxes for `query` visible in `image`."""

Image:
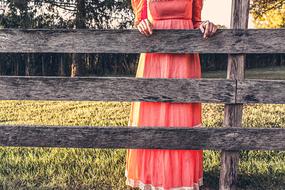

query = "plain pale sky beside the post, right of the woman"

[202,0,254,28]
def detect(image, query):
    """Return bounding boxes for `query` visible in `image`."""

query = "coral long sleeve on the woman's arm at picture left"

[131,0,147,26]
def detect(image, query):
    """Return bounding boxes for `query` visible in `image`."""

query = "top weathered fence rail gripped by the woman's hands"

[0,29,285,54]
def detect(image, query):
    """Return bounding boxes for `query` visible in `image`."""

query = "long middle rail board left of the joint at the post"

[0,76,236,103]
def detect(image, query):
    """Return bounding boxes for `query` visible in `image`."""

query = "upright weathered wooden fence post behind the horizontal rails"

[220,0,249,190]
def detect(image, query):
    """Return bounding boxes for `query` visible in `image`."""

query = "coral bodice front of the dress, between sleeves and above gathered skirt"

[149,0,192,20]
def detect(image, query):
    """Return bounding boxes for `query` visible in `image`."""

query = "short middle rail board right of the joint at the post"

[236,80,285,104]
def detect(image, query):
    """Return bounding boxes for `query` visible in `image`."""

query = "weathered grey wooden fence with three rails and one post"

[0,0,285,189]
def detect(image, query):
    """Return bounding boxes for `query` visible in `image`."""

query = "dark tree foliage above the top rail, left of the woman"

[0,0,133,29]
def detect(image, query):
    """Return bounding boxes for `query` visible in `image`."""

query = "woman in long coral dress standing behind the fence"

[125,0,217,190]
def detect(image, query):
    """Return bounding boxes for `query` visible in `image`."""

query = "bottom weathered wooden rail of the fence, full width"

[0,125,285,150]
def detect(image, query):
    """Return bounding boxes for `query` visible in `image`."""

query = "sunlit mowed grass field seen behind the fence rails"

[0,67,285,189]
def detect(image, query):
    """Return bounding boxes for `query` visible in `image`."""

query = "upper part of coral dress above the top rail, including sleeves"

[131,0,203,29]
